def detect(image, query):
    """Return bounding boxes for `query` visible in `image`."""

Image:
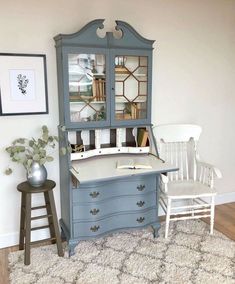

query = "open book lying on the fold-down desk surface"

[117,157,152,169]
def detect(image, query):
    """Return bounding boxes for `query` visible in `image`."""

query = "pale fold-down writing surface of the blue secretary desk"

[70,154,178,183]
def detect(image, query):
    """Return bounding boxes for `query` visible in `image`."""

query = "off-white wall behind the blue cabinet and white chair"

[0,0,235,247]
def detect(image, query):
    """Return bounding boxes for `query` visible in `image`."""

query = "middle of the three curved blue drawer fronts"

[73,192,156,221]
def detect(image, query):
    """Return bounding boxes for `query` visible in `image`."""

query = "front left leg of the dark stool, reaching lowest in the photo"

[24,193,31,265]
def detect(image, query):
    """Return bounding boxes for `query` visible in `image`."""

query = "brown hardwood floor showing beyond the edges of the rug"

[0,202,235,284]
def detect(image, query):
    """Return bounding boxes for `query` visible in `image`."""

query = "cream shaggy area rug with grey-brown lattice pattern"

[9,220,235,284]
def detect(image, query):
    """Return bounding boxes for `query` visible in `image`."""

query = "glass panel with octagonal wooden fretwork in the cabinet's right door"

[114,55,148,121]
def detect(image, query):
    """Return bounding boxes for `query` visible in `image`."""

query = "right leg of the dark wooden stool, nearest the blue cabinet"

[44,190,64,256]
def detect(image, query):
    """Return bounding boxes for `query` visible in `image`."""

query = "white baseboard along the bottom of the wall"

[0,192,235,248]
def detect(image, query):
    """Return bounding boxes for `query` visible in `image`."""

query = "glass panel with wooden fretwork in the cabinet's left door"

[68,53,107,123]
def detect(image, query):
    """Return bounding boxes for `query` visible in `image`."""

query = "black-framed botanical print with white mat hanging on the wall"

[0,53,48,115]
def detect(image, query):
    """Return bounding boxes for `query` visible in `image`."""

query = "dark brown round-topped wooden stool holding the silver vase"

[17,180,64,265]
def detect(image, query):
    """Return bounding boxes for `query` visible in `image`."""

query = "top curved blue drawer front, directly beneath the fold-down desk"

[72,175,156,202]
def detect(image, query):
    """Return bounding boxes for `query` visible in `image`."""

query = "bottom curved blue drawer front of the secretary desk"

[73,208,157,238]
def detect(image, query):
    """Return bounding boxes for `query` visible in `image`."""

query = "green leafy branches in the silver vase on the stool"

[5,125,58,175]
